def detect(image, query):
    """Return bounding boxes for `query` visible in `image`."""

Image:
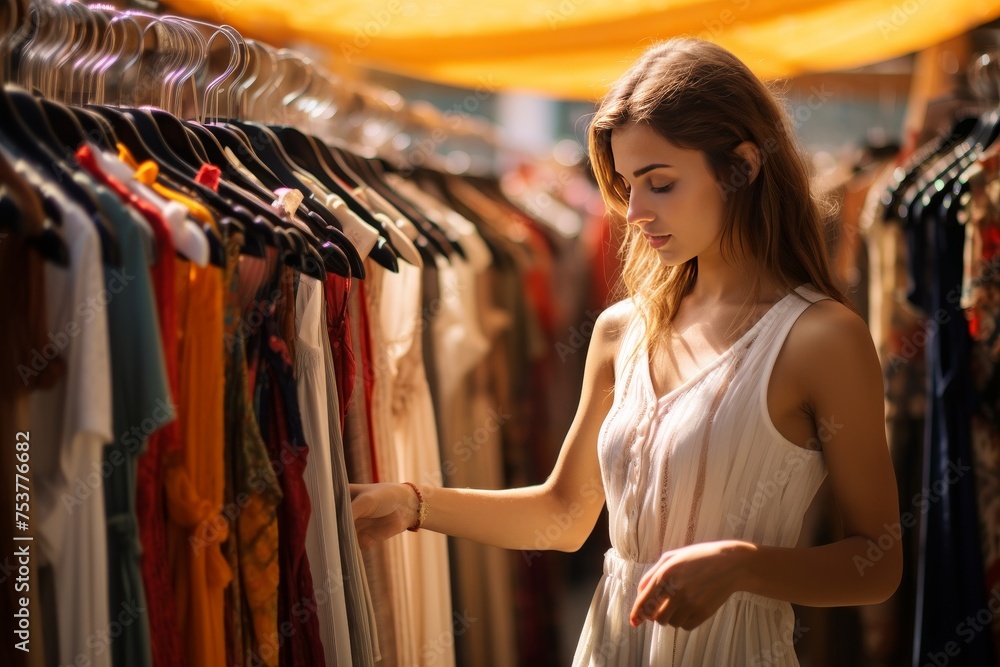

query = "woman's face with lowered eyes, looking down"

[611,124,725,266]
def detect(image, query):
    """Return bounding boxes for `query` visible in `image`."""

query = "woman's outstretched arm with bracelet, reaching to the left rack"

[351,303,629,551]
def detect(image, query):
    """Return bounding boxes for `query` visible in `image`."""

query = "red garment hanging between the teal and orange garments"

[76,144,187,667]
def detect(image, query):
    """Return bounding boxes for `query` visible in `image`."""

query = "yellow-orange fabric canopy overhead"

[166,0,1000,100]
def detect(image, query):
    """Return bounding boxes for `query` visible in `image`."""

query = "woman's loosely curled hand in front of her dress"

[629,540,754,630]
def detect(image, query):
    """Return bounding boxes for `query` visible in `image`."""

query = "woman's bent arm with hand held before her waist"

[632,301,903,629]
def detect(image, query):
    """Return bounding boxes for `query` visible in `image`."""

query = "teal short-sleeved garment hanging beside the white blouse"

[75,174,175,667]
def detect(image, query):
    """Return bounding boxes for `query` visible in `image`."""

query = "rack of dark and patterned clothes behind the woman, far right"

[824,52,1000,666]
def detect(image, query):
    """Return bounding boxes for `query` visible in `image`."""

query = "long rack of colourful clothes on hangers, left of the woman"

[0,1,591,667]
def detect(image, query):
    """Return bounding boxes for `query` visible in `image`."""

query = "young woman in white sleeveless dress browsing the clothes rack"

[351,39,902,666]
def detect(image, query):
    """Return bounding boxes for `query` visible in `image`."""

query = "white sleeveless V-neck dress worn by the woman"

[573,285,828,667]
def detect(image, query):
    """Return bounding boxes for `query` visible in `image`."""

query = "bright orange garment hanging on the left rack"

[119,153,232,667]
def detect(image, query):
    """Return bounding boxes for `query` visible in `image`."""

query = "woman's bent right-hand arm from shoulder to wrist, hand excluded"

[742,302,903,607]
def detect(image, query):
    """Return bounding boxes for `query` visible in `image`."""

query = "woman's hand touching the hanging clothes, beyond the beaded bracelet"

[349,484,419,549]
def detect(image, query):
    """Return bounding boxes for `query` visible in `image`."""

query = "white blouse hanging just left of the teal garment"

[22,163,112,665]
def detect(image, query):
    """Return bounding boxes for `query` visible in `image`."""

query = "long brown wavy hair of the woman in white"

[589,38,850,344]
